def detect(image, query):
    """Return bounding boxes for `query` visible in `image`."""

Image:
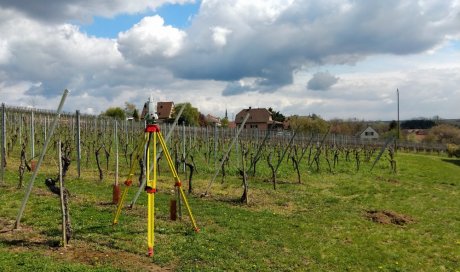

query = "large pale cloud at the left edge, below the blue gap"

[0,9,122,97]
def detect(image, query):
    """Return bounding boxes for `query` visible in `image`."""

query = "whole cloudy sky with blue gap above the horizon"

[0,0,460,120]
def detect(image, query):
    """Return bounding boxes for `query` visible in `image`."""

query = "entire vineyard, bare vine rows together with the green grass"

[0,103,460,271]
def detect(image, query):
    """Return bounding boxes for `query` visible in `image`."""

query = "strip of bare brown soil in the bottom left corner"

[0,218,173,272]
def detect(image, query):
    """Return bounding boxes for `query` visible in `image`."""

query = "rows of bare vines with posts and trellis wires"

[1,106,445,201]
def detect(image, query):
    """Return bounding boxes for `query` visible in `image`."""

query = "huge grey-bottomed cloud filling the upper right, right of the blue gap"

[151,0,460,93]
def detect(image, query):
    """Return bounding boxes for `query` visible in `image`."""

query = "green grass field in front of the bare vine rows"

[0,153,460,271]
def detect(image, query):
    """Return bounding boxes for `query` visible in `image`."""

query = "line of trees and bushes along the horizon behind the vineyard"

[101,102,460,145]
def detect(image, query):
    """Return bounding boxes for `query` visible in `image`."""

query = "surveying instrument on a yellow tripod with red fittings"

[113,96,199,256]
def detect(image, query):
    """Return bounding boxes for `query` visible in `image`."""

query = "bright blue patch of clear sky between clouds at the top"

[79,1,201,38]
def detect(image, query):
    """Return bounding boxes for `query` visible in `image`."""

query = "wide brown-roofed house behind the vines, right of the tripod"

[235,107,283,130]
